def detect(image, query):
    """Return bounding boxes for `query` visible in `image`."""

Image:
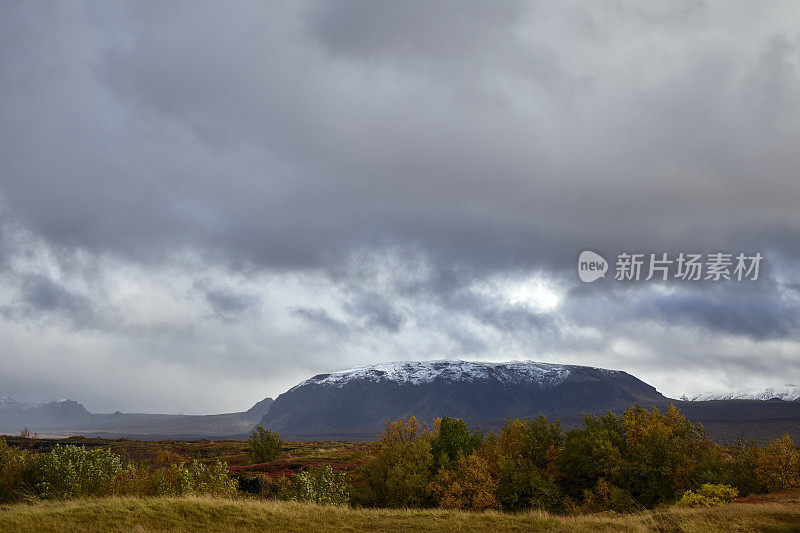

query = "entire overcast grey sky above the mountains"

[0,0,800,413]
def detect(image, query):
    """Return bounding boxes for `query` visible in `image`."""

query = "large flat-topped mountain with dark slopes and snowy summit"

[261,360,667,439]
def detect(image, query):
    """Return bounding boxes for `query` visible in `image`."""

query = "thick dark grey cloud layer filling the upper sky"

[4,3,799,276]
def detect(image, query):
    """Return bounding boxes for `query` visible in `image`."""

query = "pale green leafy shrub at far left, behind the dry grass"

[36,444,124,499]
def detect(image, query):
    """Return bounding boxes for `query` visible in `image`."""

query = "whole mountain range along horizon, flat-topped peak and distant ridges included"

[6,360,800,442]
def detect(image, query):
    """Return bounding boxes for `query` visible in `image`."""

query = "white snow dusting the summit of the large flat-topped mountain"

[291,360,570,390]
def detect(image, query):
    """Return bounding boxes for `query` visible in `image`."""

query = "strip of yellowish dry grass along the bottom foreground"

[0,498,800,533]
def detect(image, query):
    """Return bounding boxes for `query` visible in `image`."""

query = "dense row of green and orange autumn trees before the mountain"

[352,407,800,514]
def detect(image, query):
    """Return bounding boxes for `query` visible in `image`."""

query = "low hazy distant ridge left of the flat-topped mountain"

[0,396,272,439]
